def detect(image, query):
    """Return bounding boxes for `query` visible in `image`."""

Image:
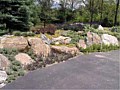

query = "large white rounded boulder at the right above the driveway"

[102,34,119,45]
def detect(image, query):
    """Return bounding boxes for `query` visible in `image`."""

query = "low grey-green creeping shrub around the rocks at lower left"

[0,48,24,83]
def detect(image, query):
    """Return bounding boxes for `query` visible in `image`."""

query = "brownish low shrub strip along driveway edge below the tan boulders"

[26,53,73,70]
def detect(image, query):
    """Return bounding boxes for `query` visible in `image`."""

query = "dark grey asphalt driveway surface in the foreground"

[3,50,120,90]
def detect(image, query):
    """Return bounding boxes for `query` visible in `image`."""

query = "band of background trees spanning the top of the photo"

[0,0,120,32]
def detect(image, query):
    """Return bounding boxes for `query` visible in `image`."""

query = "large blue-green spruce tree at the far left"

[0,0,29,32]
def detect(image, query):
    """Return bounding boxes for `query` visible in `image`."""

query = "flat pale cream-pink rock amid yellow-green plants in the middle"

[52,36,71,44]
